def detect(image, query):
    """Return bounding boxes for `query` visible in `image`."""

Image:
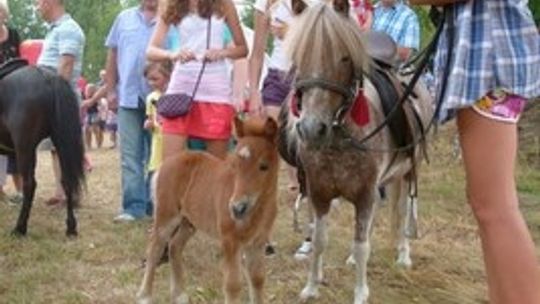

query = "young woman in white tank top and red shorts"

[147,0,247,159]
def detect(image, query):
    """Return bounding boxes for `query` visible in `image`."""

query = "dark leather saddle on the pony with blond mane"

[363,31,423,152]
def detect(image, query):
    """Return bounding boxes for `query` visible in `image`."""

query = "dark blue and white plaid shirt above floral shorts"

[435,0,540,111]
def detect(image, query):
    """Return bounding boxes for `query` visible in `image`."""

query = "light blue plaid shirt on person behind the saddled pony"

[371,0,420,50]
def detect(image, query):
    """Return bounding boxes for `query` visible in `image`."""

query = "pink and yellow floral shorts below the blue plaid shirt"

[473,89,527,123]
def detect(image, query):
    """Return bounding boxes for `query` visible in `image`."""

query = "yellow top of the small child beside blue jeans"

[146,91,163,172]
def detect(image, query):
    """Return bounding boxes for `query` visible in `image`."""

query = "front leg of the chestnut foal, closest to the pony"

[246,241,265,304]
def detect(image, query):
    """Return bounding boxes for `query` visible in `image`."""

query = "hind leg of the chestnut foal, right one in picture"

[169,219,196,304]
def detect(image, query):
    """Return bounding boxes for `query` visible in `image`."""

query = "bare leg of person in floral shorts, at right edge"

[458,109,540,304]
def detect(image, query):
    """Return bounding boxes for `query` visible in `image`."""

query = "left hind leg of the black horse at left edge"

[13,150,37,235]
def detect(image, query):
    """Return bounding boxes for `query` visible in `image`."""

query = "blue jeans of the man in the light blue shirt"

[118,103,152,218]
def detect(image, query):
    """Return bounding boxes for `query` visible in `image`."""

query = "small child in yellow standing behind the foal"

[144,61,172,180]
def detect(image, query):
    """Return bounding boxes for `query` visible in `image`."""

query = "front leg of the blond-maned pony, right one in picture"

[353,189,375,304]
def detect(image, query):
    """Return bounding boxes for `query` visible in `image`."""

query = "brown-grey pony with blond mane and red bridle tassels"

[281,0,433,304]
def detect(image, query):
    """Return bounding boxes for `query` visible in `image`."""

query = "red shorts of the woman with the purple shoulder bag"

[162,101,235,140]
